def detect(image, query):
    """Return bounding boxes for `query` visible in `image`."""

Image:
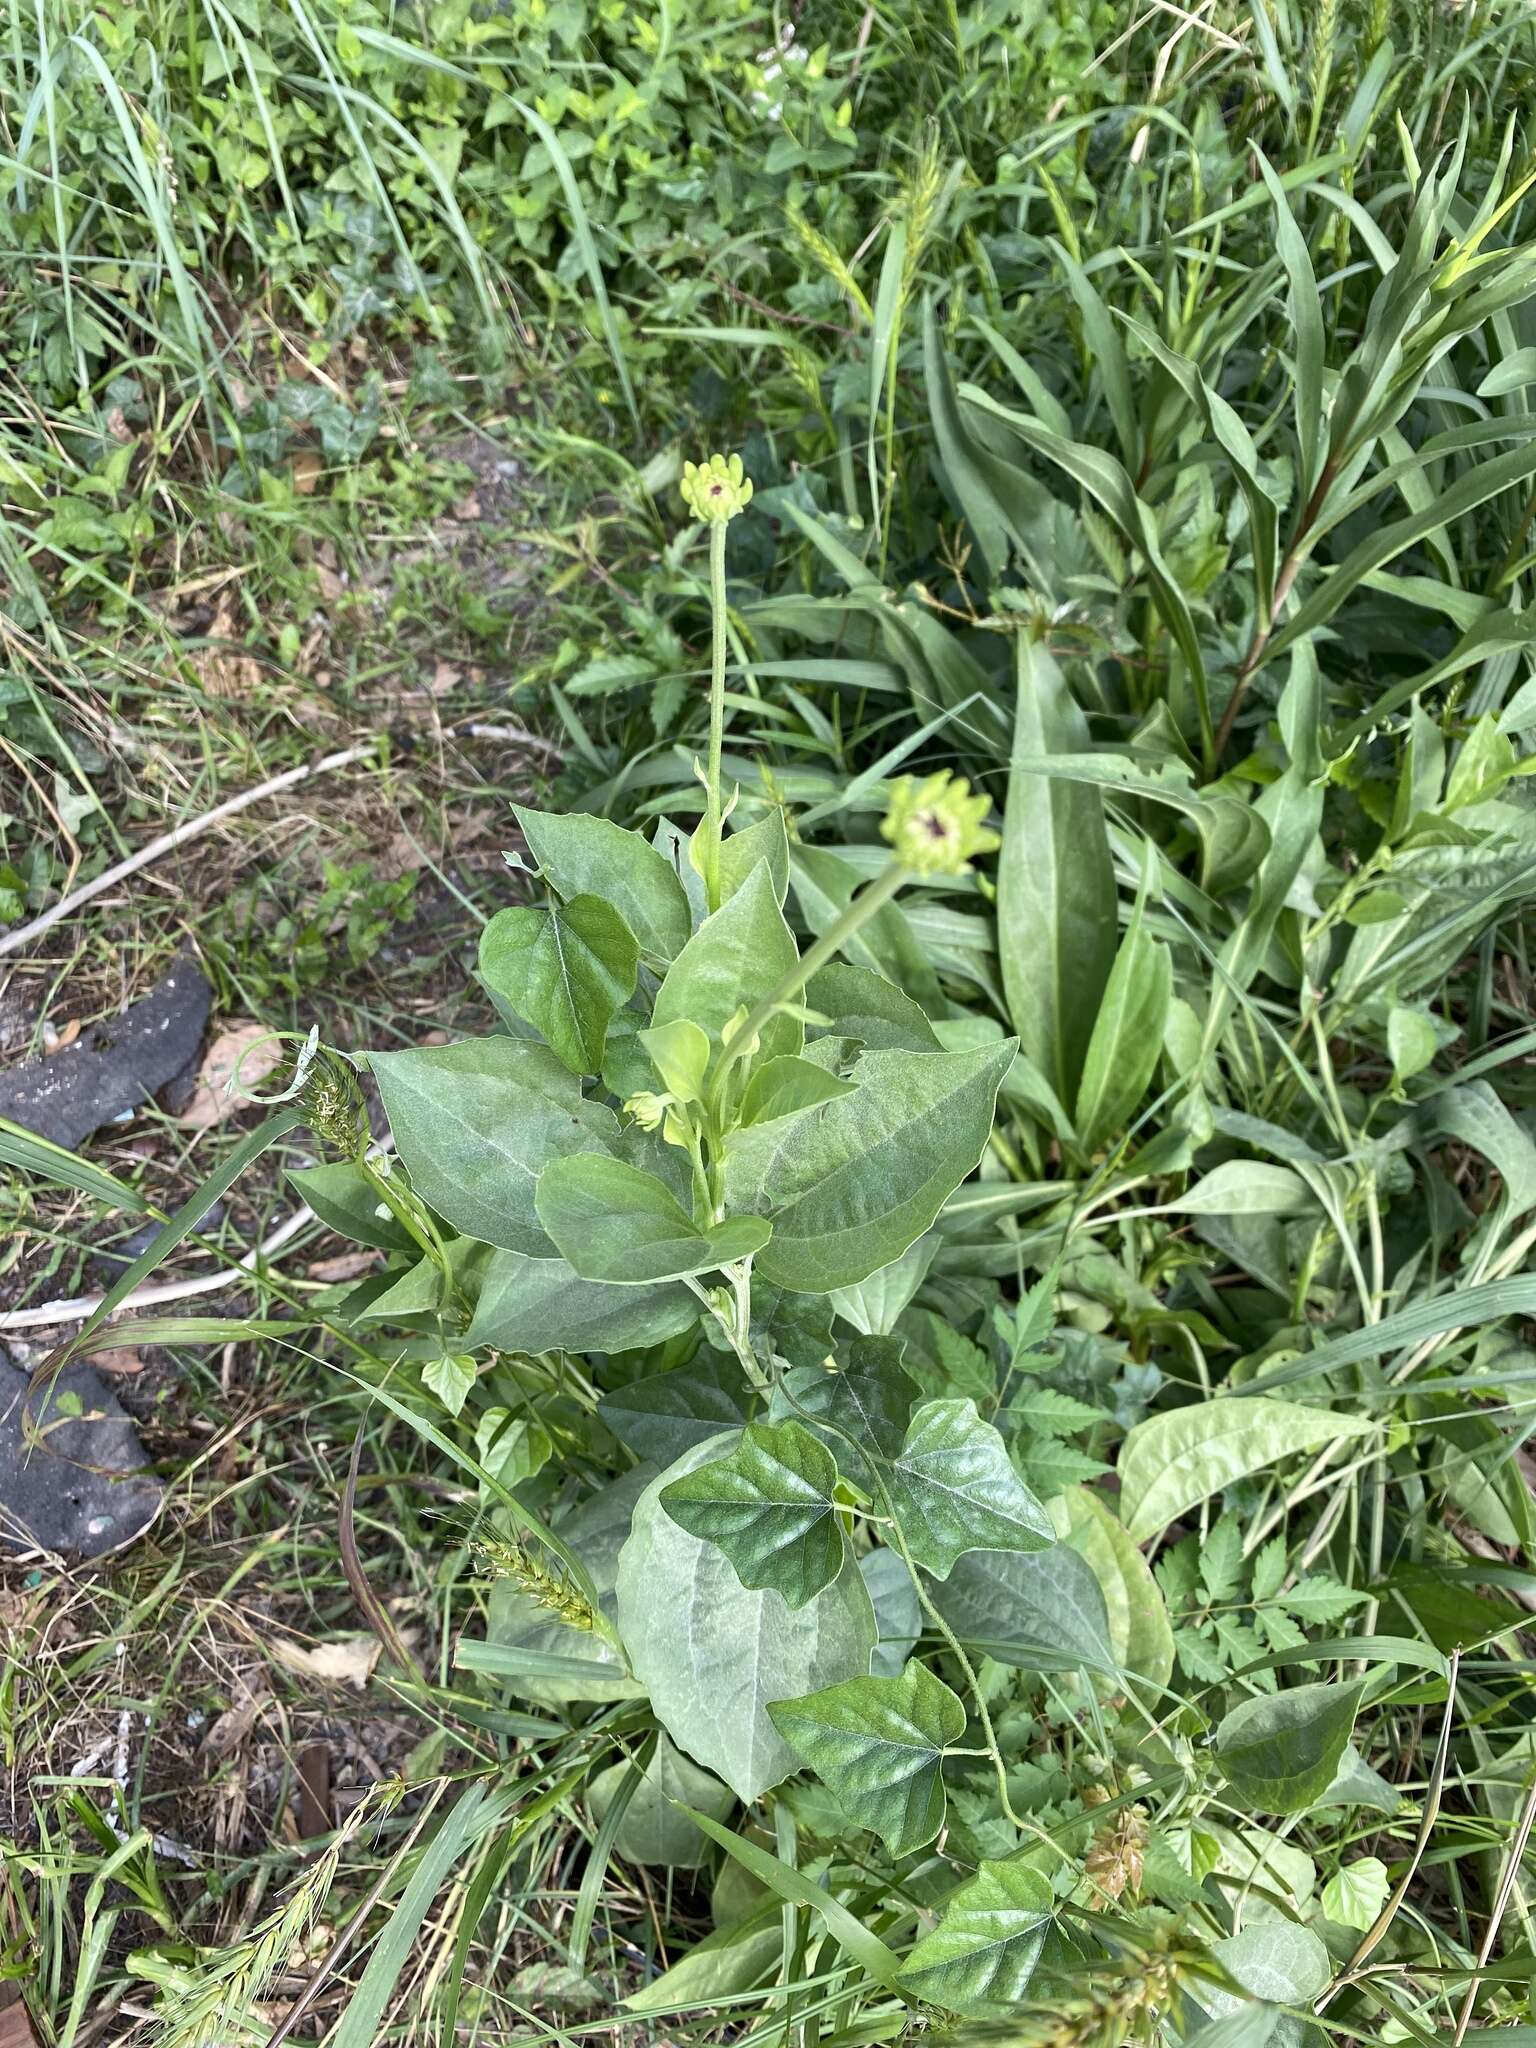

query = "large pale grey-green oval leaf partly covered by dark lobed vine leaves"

[618,1436,877,1800]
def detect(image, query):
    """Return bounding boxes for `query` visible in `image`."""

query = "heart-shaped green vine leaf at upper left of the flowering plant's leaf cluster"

[479,895,639,1073]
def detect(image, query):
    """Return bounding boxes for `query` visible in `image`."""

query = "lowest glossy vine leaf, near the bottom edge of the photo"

[901,1858,1055,2019]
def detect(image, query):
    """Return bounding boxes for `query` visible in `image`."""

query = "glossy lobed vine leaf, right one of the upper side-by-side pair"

[885,1401,1057,1579]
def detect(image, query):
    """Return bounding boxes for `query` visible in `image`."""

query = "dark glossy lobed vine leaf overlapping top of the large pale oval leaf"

[662,1421,848,1605]
